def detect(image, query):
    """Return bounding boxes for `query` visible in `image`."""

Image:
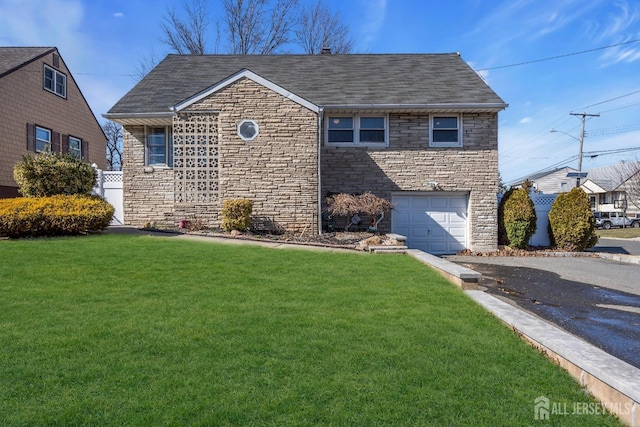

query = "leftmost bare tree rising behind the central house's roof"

[160,0,209,55]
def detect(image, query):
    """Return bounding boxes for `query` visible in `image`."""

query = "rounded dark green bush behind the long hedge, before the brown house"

[13,153,97,197]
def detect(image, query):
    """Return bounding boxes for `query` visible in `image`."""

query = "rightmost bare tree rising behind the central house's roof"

[295,0,353,54]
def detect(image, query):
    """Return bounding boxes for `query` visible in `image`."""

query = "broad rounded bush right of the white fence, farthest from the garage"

[549,187,598,252]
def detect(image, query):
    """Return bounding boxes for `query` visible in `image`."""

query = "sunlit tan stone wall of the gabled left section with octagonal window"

[124,78,318,233]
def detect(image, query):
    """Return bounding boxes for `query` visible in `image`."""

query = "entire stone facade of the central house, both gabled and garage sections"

[124,78,498,251]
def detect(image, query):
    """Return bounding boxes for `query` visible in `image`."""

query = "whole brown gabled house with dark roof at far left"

[0,47,107,197]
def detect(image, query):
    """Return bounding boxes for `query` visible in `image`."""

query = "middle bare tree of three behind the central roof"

[223,0,298,55]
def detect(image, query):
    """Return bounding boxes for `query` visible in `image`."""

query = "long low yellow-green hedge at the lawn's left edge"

[0,195,114,237]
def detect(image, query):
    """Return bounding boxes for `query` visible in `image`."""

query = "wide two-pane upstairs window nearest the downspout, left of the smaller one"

[326,115,389,146]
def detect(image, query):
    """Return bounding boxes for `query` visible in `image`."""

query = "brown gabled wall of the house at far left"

[0,49,106,191]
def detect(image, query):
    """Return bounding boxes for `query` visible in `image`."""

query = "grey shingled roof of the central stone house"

[104,53,506,118]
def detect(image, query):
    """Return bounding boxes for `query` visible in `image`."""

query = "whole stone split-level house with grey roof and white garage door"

[104,54,506,253]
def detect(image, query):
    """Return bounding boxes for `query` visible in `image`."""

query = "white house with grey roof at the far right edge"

[581,161,640,216]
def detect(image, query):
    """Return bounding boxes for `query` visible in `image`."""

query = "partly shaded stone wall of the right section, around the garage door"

[321,112,498,251]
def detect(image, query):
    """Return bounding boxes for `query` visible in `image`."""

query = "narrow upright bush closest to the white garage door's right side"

[502,188,537,249]
